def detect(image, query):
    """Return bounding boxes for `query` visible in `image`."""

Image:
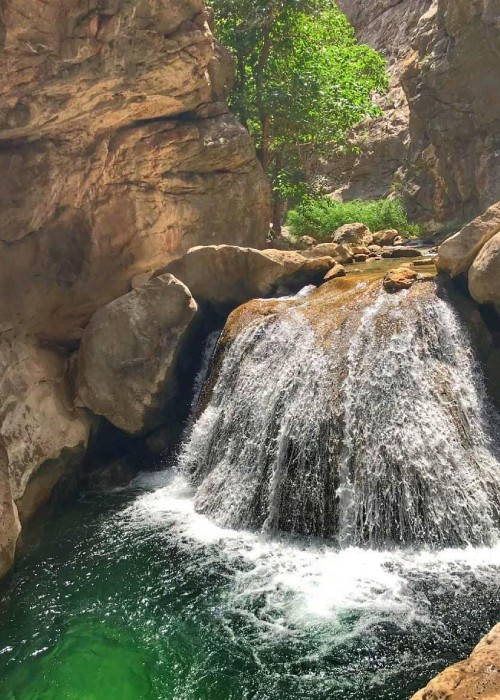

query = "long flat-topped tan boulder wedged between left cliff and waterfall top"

[160,245,335,308]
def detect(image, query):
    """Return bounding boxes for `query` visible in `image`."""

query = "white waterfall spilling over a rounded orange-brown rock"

[180,283,500,547]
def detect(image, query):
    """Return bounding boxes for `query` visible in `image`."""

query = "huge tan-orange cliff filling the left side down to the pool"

[0,0,269,573]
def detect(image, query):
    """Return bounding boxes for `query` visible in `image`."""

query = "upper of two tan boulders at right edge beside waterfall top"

[436,202,500,277]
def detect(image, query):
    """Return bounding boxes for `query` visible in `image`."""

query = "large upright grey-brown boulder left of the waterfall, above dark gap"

[77,274,197,435]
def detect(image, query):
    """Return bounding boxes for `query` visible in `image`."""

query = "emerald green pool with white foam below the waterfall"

[0,474,500,700]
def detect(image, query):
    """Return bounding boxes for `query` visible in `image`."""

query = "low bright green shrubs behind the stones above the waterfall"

[287,197,418,241]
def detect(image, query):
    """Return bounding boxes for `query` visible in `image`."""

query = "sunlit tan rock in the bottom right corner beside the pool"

[412,625,500,700]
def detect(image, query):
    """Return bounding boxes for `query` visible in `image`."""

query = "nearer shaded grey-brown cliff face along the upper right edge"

[402,0,500,220]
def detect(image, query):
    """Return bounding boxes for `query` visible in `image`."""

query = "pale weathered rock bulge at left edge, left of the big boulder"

[0,334,91,519]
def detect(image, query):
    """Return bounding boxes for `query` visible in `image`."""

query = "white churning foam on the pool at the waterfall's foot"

[120,471,500,641]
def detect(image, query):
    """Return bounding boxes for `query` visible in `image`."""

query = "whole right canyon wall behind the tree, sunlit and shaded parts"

[326,0,500,222]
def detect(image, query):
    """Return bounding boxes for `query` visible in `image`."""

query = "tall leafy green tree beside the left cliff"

[212,0,387,231]
